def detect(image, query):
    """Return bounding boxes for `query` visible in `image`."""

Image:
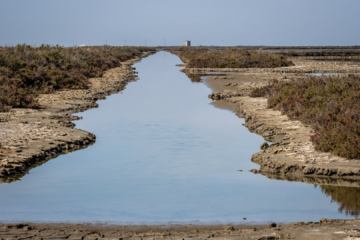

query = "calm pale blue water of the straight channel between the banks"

[0,53,356,223]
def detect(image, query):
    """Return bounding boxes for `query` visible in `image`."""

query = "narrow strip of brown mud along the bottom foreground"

[0,219,360,240]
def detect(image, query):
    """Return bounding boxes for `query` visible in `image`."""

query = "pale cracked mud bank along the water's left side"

[0,52,152,182]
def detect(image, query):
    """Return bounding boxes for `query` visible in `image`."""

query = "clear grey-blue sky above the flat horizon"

[0,0,360,46]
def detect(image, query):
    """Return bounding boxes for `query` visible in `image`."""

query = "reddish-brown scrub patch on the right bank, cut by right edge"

[250,74,360,159]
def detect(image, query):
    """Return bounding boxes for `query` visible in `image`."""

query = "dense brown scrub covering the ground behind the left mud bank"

[0,44,155,112]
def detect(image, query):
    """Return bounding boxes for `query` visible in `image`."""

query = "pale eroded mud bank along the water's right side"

[190,60,360,180]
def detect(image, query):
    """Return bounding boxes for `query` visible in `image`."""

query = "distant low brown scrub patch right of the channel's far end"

[171,47,294,68]
